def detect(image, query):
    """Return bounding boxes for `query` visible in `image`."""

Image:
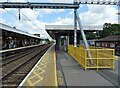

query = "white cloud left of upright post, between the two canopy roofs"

[15,17,73,39]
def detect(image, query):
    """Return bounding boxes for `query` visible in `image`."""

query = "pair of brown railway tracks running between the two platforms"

[1,45,50,87]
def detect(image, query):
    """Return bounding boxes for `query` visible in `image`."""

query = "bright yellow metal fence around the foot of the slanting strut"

[68,45,114,70]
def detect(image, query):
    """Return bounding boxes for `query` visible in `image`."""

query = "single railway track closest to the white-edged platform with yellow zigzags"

[3,46,49,88]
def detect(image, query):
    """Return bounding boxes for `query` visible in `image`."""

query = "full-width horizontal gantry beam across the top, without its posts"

[0,0,120,9]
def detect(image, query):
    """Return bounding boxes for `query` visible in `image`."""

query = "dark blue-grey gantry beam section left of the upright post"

[0,2,79,9]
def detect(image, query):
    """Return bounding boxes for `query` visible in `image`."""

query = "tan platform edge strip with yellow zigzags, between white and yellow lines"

[19,45,57,87]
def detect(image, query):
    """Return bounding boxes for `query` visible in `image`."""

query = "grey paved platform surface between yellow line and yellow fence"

[57,52,113,86]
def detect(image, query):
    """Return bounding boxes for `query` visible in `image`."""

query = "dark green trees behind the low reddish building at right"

[84,23,120,39]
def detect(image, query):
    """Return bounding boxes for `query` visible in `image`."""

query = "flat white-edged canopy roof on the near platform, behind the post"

[45,25,103,38]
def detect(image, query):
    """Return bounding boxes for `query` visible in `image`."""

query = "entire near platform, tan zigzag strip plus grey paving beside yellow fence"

[19,45,118,88]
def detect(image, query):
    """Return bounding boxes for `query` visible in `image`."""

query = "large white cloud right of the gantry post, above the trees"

[79,5,118,25]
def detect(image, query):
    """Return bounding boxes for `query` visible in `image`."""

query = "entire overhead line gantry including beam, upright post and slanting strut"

[0,0,120,63]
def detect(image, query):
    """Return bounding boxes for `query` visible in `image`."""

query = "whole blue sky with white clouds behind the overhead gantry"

[0,0,118,39]
